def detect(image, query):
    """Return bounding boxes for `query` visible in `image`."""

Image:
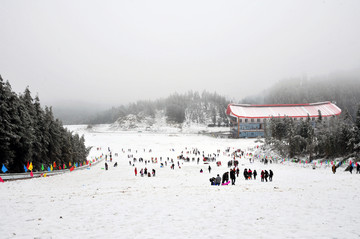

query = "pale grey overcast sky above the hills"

[0,0,360,106]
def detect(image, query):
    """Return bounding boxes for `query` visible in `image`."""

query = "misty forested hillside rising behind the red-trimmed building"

[241,74,360,121]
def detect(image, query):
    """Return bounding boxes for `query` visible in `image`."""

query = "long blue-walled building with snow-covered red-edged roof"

[226,101,341,138]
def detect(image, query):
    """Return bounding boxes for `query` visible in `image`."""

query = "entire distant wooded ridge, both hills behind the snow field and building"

[54,70,360,129]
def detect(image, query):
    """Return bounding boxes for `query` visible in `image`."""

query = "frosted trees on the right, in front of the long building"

[265,108,360,161]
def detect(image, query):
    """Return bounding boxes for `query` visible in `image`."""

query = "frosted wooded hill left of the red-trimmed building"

[89,91,229,126]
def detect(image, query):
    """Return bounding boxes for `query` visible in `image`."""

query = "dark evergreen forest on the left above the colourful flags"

[0,76,89,173]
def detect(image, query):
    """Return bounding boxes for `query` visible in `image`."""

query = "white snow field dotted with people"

[0,126,360,238]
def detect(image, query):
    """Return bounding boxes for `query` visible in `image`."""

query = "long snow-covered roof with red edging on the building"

[226,101,341,118]
